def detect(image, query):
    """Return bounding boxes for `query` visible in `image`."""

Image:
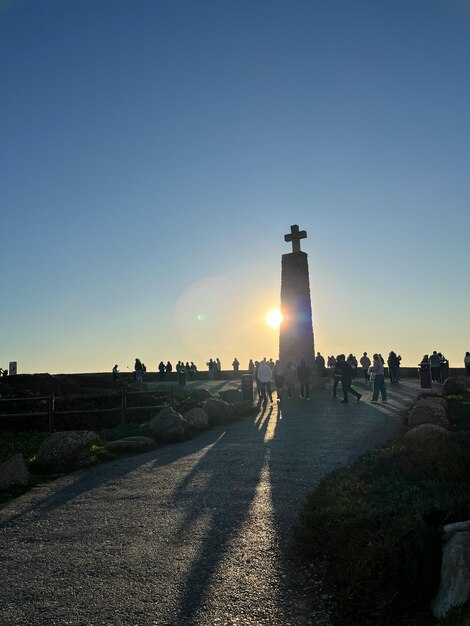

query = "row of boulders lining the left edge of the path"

[0,389,253,490]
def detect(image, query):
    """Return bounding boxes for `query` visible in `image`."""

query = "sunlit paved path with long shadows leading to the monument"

[0,381,418,626]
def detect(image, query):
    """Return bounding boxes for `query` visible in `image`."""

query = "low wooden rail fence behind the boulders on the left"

[0,387,175,432]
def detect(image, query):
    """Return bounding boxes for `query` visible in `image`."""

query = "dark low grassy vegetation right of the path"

[297,390,470,626]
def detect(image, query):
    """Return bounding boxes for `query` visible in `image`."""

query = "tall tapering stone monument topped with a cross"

[279,224,315,366]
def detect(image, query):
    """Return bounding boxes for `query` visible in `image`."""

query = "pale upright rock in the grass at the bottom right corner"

[431,531,470,618]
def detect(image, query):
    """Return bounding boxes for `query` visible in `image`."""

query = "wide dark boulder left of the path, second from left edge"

[37,430,98,468]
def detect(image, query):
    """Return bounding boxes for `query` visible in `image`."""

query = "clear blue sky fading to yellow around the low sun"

[0,0,470,373]
